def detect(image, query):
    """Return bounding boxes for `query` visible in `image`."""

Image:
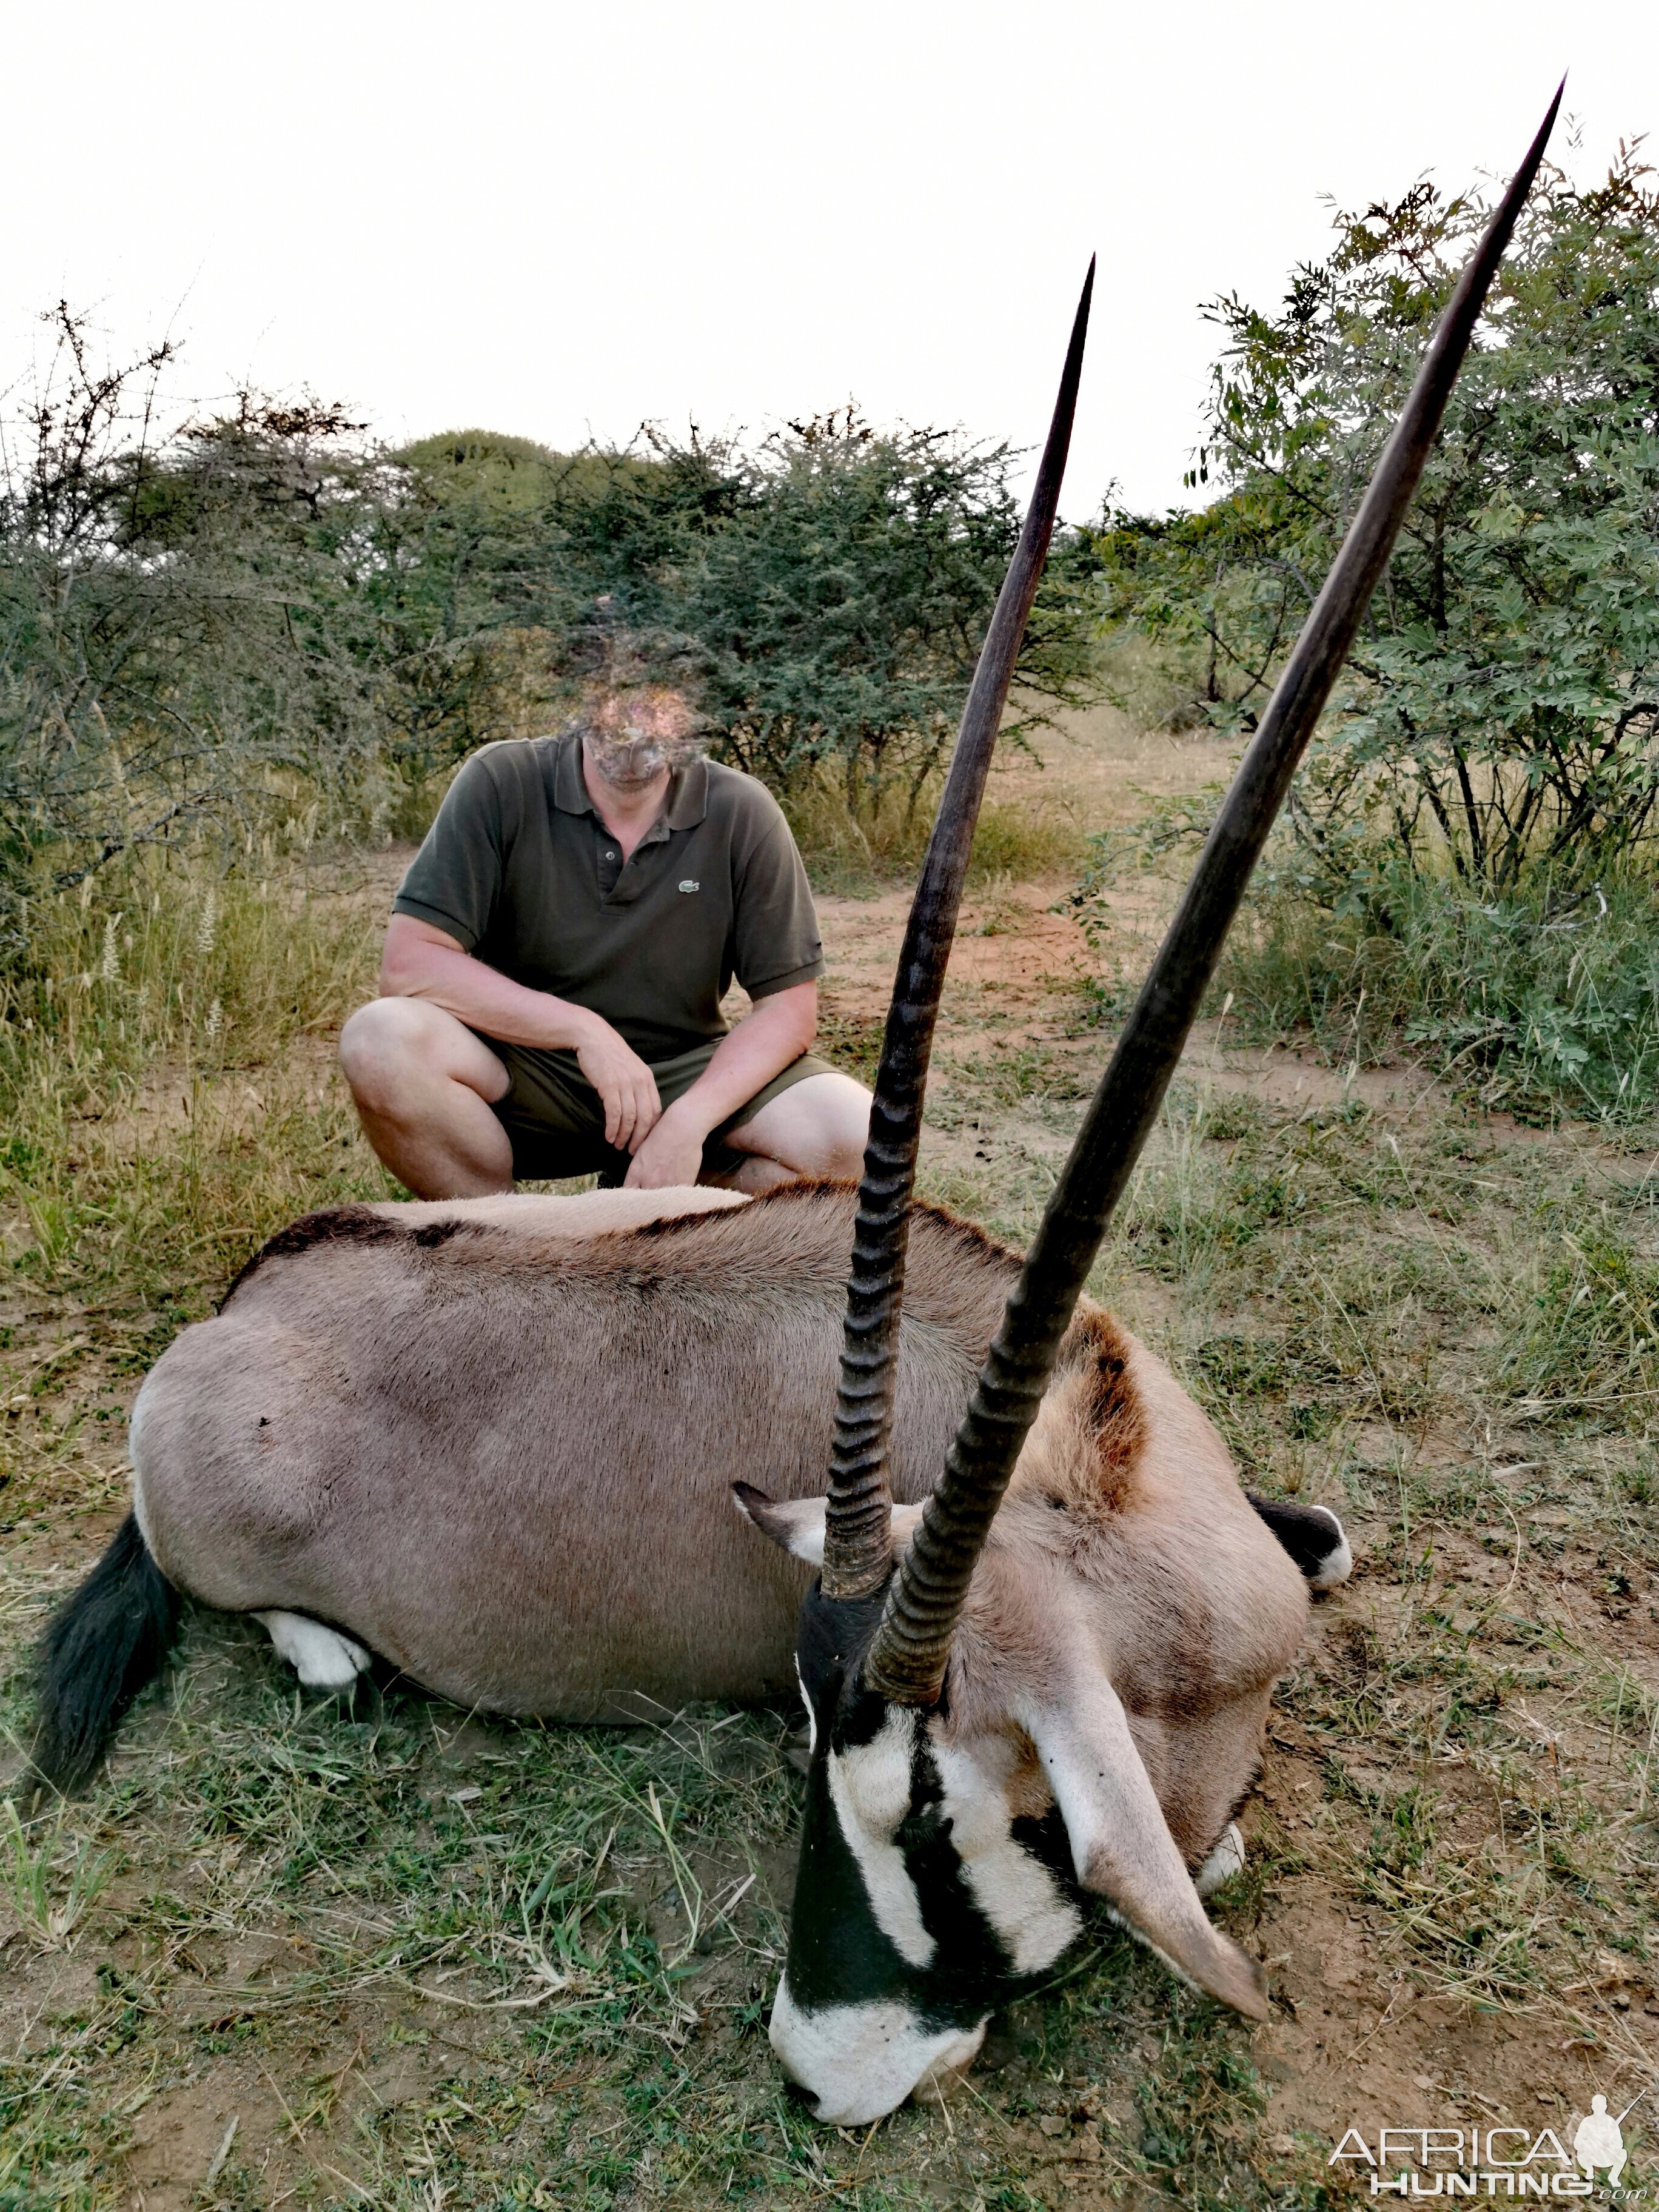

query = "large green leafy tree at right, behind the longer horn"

[1095,150,1659,898]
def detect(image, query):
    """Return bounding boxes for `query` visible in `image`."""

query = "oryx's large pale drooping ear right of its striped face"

[1027,1670,1267,2020]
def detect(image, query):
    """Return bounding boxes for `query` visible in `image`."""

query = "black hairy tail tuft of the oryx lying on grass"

[31,1513,179,1789]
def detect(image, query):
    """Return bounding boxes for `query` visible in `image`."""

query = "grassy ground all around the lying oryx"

[0,836,1659,2212]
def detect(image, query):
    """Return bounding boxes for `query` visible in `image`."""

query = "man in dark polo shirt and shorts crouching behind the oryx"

[341,686,870,1199]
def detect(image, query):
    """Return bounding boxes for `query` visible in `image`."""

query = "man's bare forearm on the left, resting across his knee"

[380,914,668,1181]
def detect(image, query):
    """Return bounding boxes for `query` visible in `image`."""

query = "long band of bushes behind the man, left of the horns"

[0,338,1095,960]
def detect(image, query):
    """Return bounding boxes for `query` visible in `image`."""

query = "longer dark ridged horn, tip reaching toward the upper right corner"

[865,91,1561,1706]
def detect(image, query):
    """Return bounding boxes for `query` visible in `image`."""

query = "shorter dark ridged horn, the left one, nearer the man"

[823,261,1095,1597]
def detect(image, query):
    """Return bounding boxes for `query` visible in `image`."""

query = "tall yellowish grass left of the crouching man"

[0,865,394,1336]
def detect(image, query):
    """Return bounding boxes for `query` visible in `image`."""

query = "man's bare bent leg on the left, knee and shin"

[341,997,513,1199]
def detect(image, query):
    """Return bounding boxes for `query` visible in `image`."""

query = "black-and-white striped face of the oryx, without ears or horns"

[772,1588,1082,2128]
